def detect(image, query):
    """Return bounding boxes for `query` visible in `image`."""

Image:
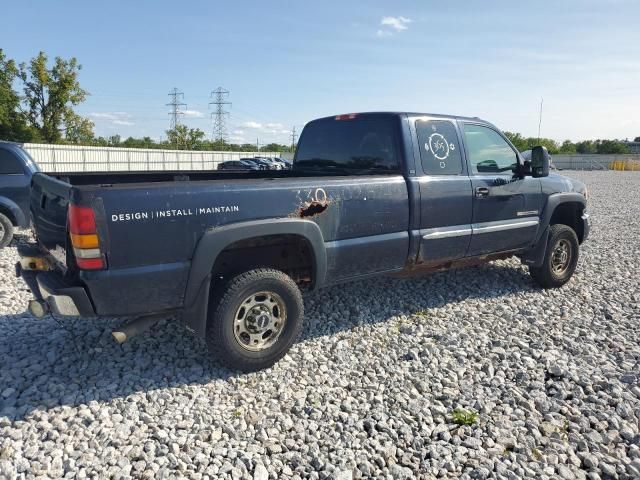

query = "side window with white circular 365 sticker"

[416,120,462,175]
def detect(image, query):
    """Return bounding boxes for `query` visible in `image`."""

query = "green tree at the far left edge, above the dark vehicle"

[0,48,33,142]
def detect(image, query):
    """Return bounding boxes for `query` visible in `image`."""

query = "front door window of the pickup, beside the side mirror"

[464,123,518,174]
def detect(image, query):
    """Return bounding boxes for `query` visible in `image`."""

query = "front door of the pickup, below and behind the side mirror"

[460,122,541,256]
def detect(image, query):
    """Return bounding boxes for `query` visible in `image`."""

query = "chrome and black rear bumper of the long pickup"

[16,246,96,317]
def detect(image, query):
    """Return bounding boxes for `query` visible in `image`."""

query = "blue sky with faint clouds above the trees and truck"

[0,0,640,143]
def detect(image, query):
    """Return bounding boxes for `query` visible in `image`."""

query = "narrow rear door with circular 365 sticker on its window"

[412,117,473,264]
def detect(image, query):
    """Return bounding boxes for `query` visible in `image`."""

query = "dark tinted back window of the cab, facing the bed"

[293,115,400,175]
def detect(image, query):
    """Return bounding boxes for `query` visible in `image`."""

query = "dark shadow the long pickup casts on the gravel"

[0,262,537,423]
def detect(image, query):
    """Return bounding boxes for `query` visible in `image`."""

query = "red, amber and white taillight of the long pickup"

[69,204,105,270]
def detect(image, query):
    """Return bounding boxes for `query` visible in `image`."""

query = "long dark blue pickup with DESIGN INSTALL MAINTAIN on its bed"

[17,113,589,370]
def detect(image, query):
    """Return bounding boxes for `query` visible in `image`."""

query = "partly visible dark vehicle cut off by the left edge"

[0,142,38,248]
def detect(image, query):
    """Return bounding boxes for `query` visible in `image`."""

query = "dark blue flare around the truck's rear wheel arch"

[183,218,327,337]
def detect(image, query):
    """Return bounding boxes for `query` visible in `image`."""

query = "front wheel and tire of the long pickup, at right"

[529,224,580,288]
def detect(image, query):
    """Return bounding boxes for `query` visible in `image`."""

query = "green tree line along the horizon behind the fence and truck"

[0,49,640,154]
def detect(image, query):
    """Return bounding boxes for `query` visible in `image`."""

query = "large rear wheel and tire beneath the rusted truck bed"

[206,268,304,372]
